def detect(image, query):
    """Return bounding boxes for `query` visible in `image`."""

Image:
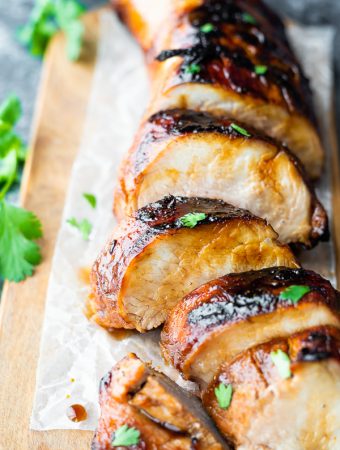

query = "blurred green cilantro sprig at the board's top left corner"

[18,0,85,61]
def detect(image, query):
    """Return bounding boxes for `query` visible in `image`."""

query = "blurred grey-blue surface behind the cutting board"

[0,0,340,144]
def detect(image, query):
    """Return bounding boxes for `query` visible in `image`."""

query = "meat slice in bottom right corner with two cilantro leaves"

[203,327,340,450]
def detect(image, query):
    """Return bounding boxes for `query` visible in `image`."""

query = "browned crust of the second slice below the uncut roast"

[89,196,266,328]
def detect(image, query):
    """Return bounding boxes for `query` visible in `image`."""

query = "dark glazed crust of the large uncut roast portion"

[113,0,316,125]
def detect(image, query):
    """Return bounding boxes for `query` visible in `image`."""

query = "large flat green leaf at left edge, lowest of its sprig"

[0,200,42,282]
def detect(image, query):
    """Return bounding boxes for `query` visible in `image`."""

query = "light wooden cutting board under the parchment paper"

[0,6,340,450]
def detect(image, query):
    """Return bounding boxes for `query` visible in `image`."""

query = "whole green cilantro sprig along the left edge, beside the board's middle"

[0,95,42,282]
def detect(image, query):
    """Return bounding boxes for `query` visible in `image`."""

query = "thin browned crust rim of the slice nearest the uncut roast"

[114,109,329,248]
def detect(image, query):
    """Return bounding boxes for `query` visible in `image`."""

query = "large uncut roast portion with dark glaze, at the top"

[113,0,324,178]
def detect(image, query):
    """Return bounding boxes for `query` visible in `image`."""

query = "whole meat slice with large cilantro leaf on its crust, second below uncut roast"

[90,196,298,331]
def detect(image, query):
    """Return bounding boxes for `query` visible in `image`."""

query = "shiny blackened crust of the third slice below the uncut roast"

[161,267,340,372]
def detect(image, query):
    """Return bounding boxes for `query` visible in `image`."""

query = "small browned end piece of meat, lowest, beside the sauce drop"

[91,353,228,450]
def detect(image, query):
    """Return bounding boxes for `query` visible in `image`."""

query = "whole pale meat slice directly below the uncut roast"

[115,110,328,246]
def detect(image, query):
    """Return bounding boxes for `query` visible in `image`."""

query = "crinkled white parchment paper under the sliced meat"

[31,12,334,430]
